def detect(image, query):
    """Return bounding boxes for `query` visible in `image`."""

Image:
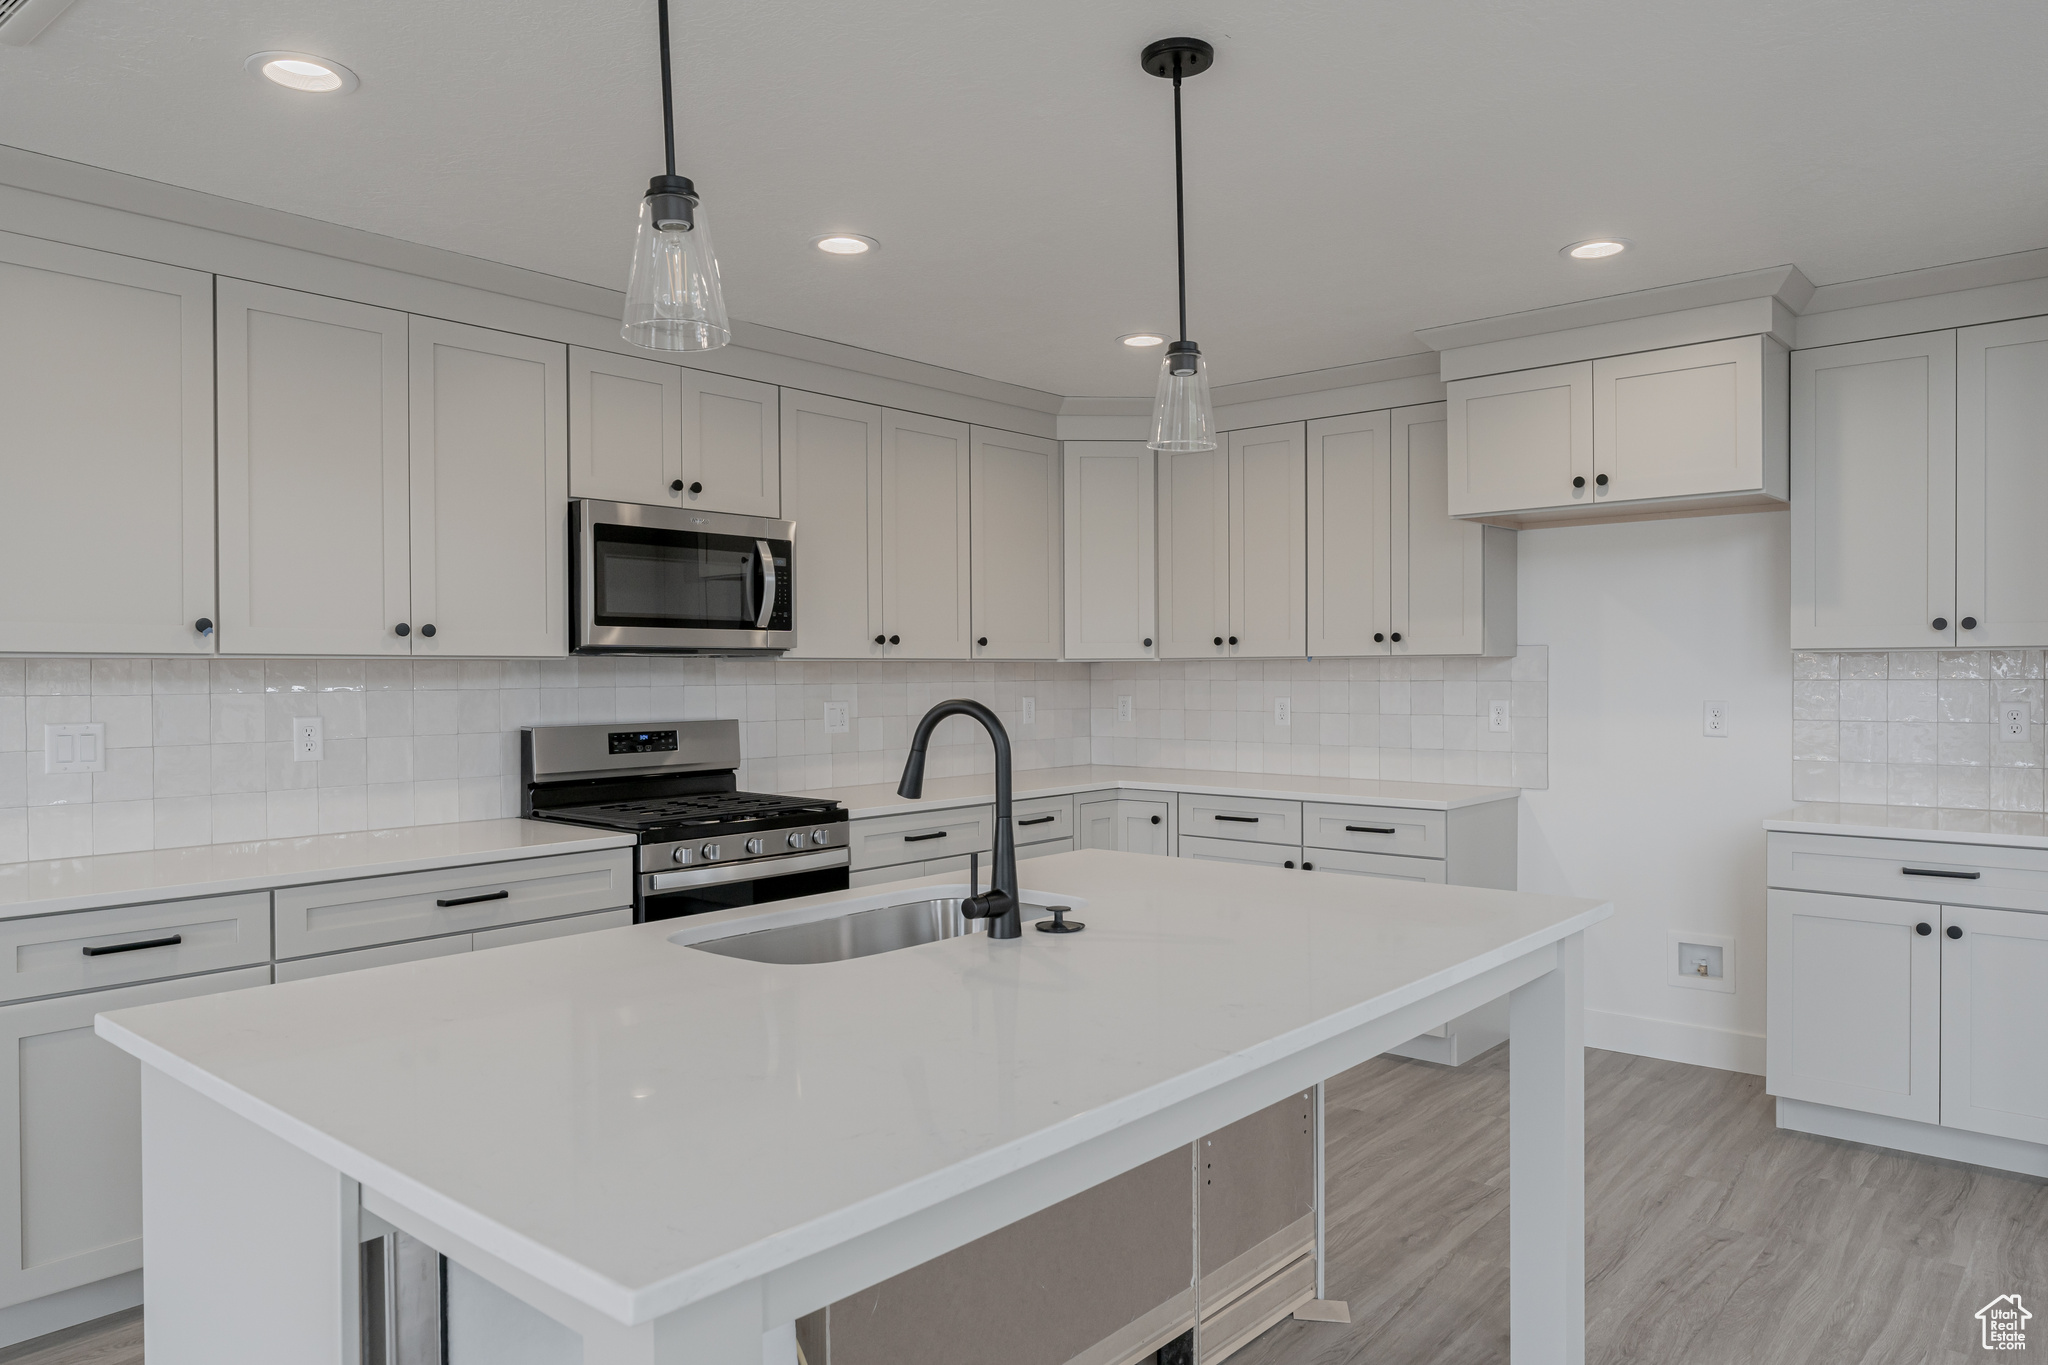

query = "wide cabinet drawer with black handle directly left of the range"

[276,849,633,960]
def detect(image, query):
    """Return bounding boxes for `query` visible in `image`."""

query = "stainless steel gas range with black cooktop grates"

[518,720,850,921]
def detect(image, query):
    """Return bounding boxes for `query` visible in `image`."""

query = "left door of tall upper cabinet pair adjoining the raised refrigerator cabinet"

[1309,403,1392,657]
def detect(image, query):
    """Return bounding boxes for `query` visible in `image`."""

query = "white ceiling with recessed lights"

[0,0,2048,395]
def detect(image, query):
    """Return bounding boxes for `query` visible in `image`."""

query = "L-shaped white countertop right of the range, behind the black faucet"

[791,765,1522,821]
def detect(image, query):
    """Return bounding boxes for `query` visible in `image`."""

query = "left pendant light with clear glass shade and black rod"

[618,0,733,350]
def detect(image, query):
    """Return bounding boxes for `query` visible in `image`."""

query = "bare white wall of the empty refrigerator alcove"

[1518,512,1792,1074]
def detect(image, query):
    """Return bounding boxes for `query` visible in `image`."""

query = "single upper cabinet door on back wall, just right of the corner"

[1061,440,1157,659]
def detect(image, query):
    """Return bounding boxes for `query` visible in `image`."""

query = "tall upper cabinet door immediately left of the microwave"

[412,317,569,659]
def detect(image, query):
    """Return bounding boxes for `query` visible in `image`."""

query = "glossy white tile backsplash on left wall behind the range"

[0,659,1090,862]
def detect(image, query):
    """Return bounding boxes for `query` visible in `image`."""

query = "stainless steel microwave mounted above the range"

[569,497,797,655]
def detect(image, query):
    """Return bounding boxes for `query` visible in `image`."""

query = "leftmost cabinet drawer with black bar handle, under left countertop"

[0,890,270,1001]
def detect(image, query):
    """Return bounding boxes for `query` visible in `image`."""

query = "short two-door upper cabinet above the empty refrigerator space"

[1446,336,1788,524]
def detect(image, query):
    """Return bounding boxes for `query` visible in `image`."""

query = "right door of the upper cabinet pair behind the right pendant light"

[1231,422,1309,659]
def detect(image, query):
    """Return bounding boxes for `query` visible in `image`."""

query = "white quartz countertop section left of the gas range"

[0,821,633,919]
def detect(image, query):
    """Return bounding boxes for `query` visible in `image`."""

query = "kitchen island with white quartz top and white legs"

[98,851,1612,1365]
